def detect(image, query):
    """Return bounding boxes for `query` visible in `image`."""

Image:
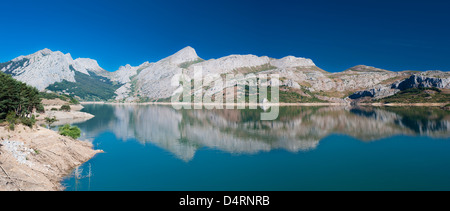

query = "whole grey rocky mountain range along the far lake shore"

[0,47,450,103]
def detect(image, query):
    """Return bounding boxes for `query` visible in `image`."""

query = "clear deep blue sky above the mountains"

[0,0,450,72]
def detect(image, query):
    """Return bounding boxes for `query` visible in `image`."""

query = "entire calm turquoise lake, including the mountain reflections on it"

[63,105,450,191]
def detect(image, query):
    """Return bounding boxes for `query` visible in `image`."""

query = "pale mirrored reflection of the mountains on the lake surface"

[76,104,450,161]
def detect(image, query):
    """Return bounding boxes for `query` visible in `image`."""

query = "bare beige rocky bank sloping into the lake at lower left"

[0,125,102,191]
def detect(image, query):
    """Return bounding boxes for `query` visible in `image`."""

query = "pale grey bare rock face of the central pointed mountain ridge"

[130,47,323,99]
